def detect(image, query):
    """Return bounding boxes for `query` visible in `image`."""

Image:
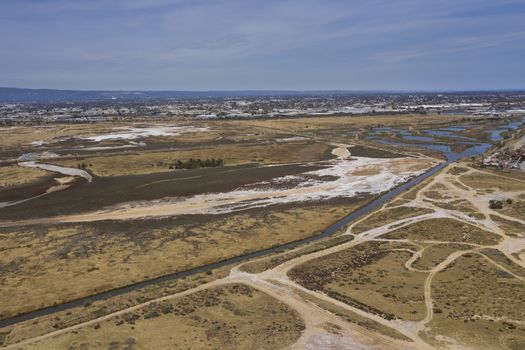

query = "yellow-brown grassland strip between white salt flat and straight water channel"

[0,201,360,317]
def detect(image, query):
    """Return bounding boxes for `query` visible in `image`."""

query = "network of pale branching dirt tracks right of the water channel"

[2,160,525,349]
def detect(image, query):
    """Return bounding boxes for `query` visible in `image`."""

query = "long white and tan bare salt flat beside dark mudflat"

[0,145,437,226]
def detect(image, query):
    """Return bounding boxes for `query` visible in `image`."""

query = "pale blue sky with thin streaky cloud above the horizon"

[0,0,525,90]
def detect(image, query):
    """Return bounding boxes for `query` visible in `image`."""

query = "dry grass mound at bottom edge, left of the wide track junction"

[7,284,304,350]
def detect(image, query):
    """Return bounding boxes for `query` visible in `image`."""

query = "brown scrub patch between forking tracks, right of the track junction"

[288,242,427,320]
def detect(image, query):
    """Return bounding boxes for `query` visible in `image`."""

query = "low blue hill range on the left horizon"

[0,87,360,103]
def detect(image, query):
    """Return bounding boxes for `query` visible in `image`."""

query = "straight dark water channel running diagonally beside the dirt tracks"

[0,117,520,328]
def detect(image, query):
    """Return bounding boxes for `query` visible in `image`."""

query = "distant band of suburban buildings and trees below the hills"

[0,92,525,125]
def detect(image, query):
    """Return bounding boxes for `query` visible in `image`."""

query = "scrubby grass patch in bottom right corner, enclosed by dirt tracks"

[429,254,525,349]
